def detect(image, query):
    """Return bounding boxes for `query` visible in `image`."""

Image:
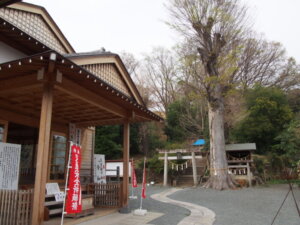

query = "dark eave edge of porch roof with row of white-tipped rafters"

[0,50,163,121]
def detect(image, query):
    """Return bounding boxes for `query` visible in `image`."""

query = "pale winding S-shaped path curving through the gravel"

[151,188,216,225]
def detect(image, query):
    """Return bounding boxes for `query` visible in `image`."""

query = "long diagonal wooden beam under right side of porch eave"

[55,77,129,118]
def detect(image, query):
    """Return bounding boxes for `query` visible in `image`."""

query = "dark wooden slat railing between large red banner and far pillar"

[87,182,122,208]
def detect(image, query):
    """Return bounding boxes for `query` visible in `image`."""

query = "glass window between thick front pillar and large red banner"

[49,133,67,180]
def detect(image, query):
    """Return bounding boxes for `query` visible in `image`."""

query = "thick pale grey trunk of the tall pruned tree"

[204,85,235,190]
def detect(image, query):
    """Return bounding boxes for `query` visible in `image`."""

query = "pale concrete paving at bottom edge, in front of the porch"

[79,212,163,225]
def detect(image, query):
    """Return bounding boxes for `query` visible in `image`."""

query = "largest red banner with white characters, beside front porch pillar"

[66,145,82,214]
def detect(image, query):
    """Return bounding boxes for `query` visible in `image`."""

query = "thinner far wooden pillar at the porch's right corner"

[122,122,130,207]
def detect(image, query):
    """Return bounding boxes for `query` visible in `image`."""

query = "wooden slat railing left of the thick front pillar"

[0,189,33,225]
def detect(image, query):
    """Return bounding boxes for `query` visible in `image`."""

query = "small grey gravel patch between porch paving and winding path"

[129,186,190,225]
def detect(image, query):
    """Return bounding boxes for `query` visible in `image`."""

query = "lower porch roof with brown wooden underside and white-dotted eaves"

[0,51,162,130]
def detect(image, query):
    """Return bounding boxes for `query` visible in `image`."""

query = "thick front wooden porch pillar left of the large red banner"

[31,84,53,225]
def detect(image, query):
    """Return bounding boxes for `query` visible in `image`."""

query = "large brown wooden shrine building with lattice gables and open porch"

[0,3,162,225]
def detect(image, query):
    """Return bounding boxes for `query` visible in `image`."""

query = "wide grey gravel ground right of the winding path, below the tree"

[169,185,300,225]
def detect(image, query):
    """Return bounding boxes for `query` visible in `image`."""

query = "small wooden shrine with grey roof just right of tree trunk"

[225,143,256,186]
